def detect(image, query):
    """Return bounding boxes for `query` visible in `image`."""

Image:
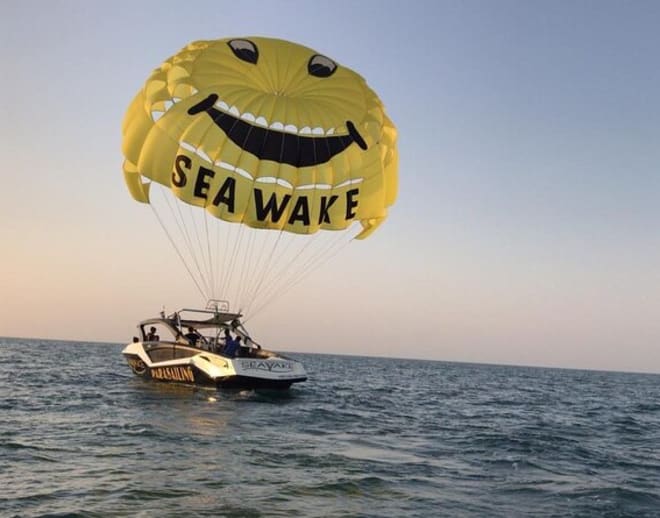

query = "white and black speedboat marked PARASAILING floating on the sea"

[122,301,307,389]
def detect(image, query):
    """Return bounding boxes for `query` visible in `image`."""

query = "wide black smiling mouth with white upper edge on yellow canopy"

[188,94,367,167]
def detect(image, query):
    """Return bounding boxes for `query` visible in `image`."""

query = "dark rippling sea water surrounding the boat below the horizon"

[0,338,660,517]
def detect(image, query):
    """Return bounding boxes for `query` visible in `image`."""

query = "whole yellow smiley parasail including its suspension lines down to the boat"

[122,37,398,316]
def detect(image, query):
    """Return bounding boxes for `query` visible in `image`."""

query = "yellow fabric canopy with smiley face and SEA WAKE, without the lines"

[123,37,397,237]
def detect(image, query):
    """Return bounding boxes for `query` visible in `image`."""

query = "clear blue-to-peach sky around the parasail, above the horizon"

[0,0,660,373]
